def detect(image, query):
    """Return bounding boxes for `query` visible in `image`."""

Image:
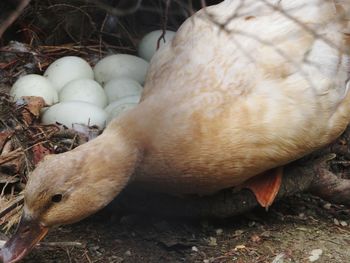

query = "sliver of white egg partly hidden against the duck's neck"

[105,95,141,123]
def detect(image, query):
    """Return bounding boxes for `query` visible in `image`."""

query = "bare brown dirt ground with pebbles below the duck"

[15,194,350,263]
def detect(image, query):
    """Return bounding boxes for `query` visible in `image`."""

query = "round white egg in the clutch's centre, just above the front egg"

[58,79,107,108]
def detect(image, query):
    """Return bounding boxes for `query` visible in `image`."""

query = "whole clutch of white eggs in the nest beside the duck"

[10,30,175,128]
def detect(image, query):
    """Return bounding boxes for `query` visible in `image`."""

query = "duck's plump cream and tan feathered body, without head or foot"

[114,0,350,194]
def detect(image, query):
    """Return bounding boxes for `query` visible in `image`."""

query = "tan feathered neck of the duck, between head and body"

[73,121,140,208]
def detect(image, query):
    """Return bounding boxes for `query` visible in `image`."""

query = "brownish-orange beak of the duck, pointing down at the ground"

[0,215,48,263]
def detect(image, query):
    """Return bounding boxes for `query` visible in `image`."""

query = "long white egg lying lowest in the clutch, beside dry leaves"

[41,101,108,128]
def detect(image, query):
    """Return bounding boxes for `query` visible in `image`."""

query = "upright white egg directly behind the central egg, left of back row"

[44,56,94,92]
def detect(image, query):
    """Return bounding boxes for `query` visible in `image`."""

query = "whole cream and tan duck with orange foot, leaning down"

[0,0,350,263]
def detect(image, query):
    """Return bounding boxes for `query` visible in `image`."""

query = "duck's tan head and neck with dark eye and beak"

[0,127,138,263]
